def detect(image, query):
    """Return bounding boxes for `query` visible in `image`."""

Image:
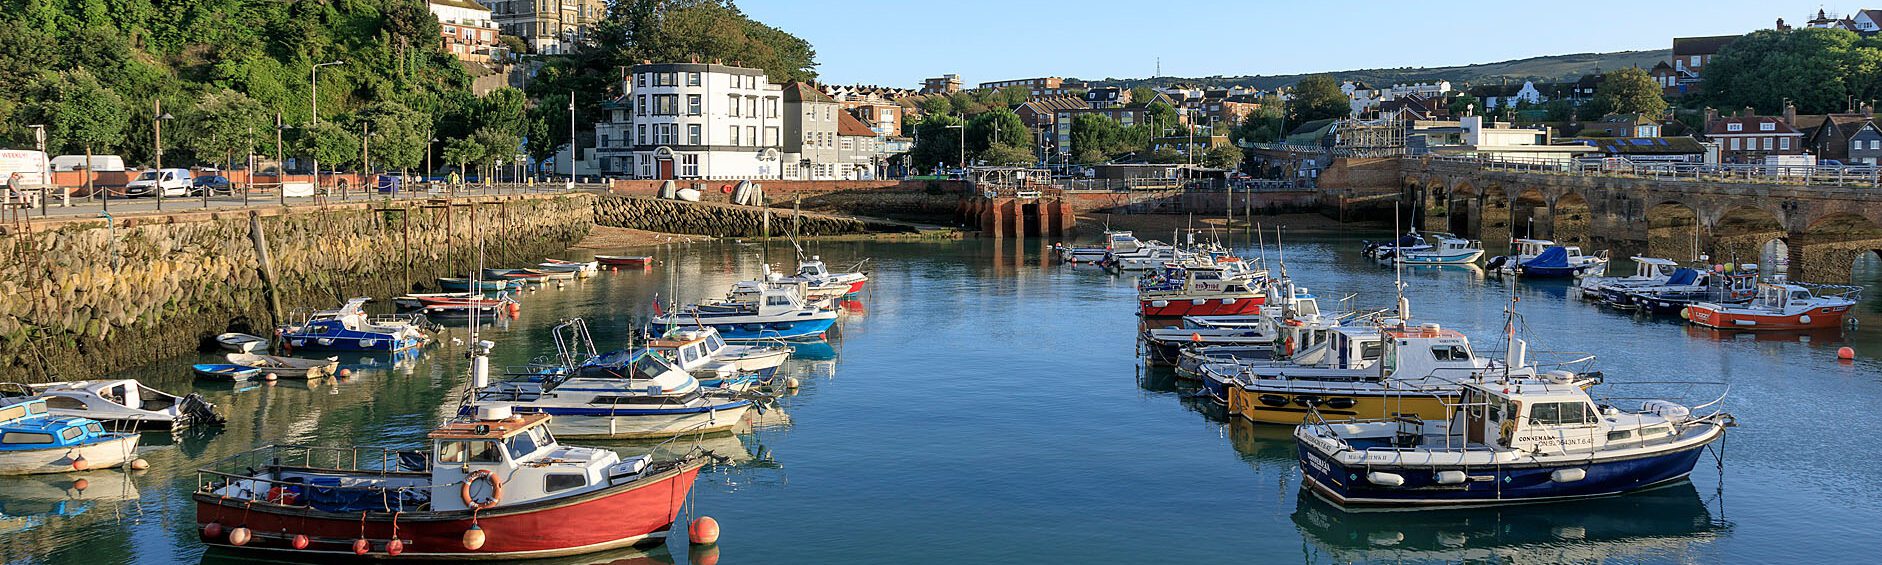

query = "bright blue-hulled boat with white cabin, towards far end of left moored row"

[653,288,837,341]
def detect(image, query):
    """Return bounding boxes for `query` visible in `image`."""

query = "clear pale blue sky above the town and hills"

[738,0,1851,87]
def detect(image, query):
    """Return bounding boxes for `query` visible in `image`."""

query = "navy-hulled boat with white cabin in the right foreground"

[1295,375,1733,507]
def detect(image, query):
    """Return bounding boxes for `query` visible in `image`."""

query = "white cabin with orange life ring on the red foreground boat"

[431,407,653,510]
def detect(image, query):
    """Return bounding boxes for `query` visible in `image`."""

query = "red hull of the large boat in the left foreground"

[196,463,700,559]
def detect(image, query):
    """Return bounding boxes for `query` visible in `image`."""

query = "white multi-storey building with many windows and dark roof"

[595,62,785,179]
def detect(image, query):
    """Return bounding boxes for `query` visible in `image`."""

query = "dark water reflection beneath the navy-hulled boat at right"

[1293,480,1731,563]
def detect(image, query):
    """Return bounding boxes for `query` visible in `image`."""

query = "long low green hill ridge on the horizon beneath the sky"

[1092,49,1671,90]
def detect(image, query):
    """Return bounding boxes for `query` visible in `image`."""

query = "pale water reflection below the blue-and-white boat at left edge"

[0,469,139,534]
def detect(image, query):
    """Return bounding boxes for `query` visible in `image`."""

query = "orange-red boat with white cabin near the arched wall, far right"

[1683,283,1863,330]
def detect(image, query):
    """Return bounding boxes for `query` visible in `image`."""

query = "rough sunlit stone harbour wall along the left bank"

[0,194,595,382]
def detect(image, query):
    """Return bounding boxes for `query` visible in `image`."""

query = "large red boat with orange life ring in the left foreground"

[194,407,704,559]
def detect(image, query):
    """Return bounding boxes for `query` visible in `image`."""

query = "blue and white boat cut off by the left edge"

[0,397,137,475]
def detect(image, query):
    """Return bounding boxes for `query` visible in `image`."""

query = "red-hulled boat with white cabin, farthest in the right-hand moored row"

[1137,260,1267,318]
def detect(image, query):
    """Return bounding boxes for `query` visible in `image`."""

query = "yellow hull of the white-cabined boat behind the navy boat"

[1204,386,1459,426]
